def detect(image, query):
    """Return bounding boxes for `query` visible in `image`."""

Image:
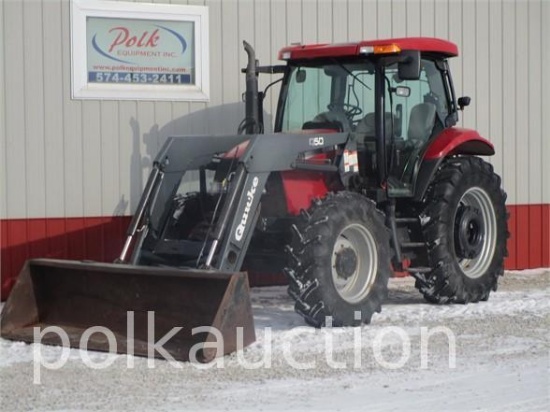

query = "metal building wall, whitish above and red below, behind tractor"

[0,0,550,297]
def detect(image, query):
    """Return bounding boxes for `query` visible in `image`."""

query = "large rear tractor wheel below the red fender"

[416,156,508,303]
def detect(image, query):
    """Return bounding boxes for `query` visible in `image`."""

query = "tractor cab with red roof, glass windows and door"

[275,39,458,197]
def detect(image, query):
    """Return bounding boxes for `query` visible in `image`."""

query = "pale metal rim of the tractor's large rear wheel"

[455,187,497,279]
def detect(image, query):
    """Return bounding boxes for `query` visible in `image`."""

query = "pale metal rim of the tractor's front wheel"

[331,223,378,303]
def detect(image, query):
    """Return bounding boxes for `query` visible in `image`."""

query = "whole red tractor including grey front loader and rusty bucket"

[2,38,507,358]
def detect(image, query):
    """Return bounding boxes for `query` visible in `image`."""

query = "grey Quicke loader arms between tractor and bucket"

[133,133,348,272]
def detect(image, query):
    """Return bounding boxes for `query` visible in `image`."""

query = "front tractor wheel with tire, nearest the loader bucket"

[285,192,391,327]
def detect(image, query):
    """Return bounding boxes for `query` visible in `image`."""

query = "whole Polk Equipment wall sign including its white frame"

[71,0,209,101]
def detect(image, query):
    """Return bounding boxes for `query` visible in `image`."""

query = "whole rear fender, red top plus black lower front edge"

[414,127,495,201]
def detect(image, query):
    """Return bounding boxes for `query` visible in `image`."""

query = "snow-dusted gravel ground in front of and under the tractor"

[0,269,550,412]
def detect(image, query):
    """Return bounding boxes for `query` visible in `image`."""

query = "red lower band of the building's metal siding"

[0,204,550,299]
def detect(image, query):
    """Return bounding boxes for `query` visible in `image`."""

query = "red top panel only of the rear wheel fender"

[424,127,495,160]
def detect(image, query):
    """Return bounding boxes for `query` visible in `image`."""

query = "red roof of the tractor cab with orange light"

[279,37,458,60]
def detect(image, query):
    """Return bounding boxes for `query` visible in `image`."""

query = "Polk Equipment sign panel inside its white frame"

[86,17,195,85]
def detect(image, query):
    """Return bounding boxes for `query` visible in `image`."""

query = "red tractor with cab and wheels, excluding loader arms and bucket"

[237,38,507,326]
